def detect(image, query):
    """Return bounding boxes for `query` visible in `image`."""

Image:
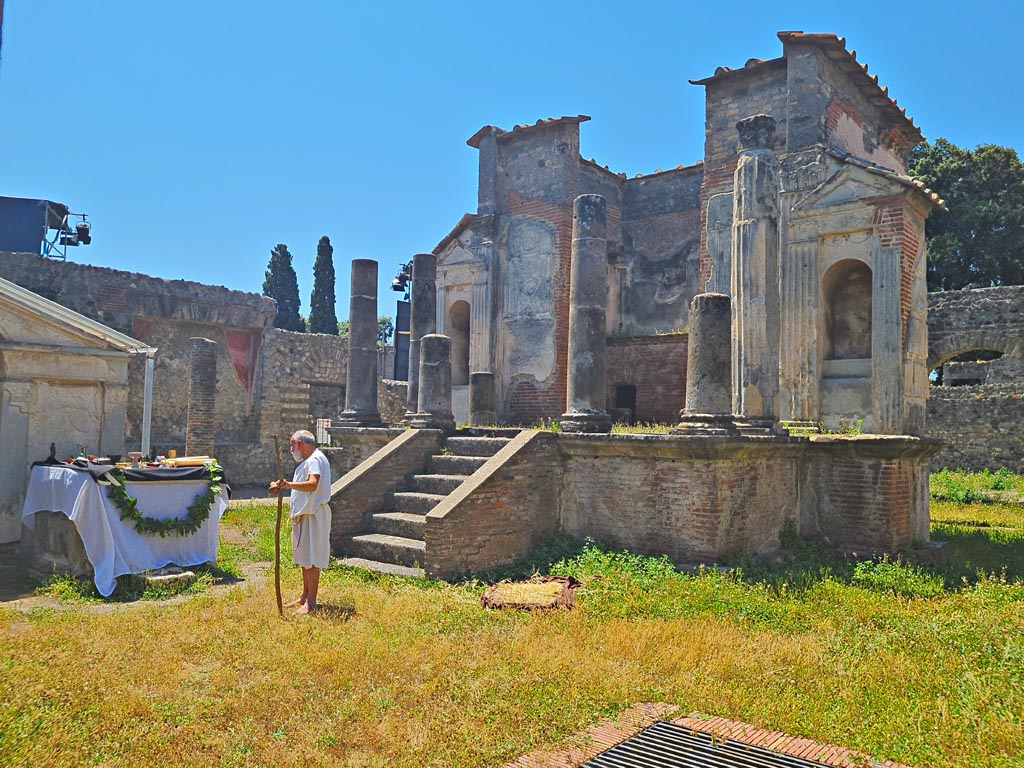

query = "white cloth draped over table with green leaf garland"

[22,467,227,597]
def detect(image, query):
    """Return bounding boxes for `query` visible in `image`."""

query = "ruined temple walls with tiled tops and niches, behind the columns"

[434,32,941,434]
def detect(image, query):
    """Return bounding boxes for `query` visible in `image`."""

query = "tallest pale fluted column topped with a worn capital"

[731,115,779,432]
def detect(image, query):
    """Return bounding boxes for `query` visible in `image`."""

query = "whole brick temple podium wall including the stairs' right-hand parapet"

[411,431,935,578]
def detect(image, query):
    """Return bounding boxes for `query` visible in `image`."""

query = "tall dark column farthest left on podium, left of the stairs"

[338,259,381,427]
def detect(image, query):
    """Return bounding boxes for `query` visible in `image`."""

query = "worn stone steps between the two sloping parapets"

[340,430,518,579]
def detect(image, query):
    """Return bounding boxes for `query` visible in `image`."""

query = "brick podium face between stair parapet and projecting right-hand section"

[558,435,801,562]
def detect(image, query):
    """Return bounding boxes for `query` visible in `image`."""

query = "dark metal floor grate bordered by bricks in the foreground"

[581,722,827,768]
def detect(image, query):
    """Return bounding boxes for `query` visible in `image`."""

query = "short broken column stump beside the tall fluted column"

[672,293,736,434]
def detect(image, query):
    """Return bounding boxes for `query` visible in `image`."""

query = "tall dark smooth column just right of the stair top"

[561,195,611,432]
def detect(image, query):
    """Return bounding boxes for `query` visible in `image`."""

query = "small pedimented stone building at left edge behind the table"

[0,280,147,544]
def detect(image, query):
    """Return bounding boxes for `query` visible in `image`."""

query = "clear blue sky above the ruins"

[0,0,1024,318]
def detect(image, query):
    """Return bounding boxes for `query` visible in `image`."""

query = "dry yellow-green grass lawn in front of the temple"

[0,483,1024,768]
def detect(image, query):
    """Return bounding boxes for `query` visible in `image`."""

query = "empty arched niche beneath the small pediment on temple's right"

[821,259,871,360]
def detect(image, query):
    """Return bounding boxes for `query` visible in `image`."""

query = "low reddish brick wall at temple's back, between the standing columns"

[607,334,689,424]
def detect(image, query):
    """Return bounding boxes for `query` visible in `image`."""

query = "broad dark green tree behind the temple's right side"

[910,138,1024,291]
